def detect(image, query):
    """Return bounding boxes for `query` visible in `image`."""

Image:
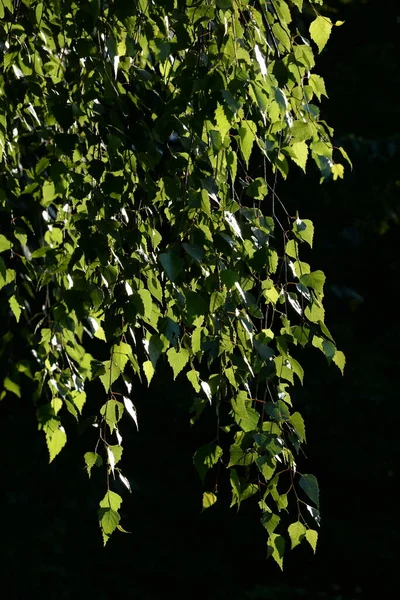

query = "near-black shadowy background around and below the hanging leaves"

[0,0,400,600]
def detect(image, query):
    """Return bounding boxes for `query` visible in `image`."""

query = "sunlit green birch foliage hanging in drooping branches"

[0,0,347,567]
